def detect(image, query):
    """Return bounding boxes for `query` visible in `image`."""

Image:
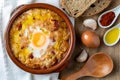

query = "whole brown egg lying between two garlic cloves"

[81,30,100,48]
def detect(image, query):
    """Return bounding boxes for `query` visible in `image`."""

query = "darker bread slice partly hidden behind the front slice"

[82,0,112,16]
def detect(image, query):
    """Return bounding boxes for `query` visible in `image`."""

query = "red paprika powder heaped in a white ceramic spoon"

[100,12,115,26]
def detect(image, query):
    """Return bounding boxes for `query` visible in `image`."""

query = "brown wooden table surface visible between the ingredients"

[60,0,120,80]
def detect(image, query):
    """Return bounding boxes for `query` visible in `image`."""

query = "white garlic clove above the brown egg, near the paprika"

[83,19,97,30]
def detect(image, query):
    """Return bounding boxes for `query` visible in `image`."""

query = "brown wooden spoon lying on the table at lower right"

[61,52,113,80]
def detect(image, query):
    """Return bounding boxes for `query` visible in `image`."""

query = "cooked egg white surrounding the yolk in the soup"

[28,27,54,58]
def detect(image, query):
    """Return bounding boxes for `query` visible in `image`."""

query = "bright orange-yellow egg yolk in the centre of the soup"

[32,32,46,47]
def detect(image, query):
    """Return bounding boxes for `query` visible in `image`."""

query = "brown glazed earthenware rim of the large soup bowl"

[4,3,75,74]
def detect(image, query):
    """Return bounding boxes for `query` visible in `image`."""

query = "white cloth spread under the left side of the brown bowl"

[0,0,74,80]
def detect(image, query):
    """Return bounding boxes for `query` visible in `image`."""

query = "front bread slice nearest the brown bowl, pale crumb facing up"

[60,0,96,18]
